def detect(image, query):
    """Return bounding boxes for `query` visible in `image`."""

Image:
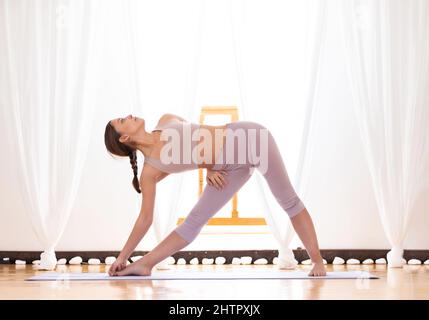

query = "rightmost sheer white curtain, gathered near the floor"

[339,0,429,267]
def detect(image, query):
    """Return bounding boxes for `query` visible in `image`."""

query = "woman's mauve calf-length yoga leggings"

[174,121,305,243]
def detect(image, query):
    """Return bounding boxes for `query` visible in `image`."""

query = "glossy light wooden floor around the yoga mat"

[0,265,429,300]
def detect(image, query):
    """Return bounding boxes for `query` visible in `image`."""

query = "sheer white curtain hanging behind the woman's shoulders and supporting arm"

[121,0,206,269]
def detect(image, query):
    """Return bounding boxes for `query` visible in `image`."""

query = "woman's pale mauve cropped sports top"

[144,121,200,173]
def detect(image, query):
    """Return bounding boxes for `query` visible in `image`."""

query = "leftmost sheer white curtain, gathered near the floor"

[0,0,97,270]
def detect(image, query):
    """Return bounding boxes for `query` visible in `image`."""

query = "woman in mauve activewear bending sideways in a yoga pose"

[104,114,326,276]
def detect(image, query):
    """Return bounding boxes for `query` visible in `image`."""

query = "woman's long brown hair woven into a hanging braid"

[104,121,141,193]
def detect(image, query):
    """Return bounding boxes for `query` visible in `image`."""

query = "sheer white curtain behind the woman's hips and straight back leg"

[229,0,326,269]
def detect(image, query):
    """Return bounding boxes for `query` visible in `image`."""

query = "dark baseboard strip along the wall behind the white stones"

[0,249,429,264]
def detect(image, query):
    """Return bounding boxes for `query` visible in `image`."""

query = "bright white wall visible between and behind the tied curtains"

[0,0,429,251]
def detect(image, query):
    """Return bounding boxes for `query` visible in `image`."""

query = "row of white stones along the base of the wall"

[3,256,429,265]
